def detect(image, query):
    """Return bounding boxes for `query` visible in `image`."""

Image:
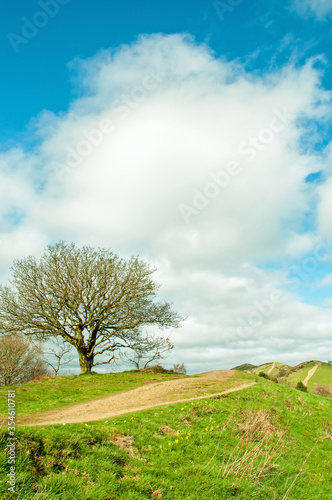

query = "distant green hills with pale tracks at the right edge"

[241,360,332,397]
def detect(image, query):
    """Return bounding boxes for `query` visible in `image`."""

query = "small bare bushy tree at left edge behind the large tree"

[0,334,49,385]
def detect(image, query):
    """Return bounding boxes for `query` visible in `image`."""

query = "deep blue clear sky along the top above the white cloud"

[0,0,332,140]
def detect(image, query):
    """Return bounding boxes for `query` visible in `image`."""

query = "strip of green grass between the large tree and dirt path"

[0,370,186,416]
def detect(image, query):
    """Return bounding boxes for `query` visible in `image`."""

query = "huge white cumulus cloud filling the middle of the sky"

[0,35,332,370]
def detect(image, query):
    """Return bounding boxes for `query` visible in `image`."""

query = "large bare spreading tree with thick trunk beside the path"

[0,241,182,374]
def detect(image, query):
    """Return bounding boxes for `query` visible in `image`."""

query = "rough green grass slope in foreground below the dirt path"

[0,380,332,500]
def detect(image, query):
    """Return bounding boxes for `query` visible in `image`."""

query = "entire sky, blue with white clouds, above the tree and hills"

[0,0,332,371]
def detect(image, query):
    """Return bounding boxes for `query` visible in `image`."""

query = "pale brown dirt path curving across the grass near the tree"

[18,370,255,426]
